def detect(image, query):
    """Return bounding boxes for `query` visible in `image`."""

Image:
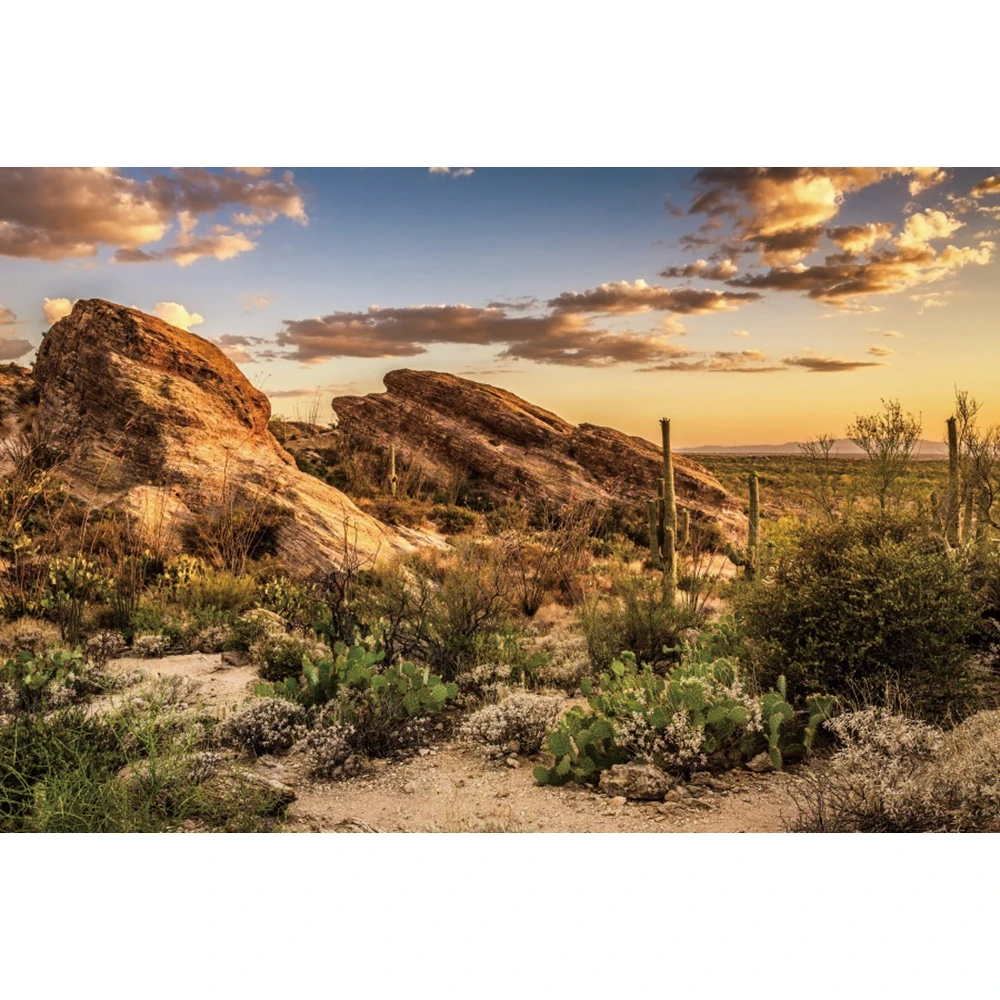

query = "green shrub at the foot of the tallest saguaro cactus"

[580,573,705,670]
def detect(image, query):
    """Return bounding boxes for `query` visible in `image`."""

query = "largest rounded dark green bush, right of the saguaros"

[733,513,977,704]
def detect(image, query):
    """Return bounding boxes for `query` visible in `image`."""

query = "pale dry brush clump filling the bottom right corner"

[793,708,1000,833]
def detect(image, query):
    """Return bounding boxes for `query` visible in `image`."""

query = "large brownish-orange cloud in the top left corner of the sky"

[0,167,308,264]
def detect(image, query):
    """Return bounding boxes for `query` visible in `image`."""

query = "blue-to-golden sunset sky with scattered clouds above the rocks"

[0,167,1000,447]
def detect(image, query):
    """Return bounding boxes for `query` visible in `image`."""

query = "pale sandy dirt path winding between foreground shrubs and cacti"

[101,654,795,833]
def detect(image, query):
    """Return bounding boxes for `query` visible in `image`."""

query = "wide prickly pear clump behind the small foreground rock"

[535,649,834,785]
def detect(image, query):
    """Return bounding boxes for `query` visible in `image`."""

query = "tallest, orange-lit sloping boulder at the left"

[33,299,411,571]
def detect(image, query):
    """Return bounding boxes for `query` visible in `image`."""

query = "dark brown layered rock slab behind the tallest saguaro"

[333,369,743,526]
